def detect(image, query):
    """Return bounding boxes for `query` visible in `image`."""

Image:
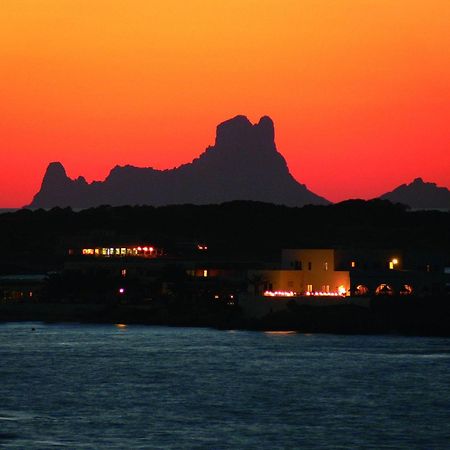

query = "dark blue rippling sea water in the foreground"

[0,323,450,450]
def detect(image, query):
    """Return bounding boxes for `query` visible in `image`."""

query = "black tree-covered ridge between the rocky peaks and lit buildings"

[0,200,450,272]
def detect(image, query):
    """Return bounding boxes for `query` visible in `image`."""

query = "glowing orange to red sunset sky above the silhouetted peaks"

[0,0,450,207]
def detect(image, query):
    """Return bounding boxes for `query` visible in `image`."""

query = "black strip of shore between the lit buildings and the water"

[0,299,450,337]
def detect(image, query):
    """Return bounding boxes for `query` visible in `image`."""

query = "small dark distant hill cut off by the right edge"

[379,178,450,210]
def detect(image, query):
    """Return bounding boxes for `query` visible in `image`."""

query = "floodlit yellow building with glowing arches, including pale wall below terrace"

[240,249,450,317]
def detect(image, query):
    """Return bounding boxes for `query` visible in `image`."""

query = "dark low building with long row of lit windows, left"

[63,243,250,301]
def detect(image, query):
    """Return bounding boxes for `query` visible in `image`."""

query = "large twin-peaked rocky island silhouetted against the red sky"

[29,116,329,208]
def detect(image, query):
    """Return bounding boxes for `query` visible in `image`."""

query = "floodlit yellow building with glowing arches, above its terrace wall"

[250,249,445,297]
